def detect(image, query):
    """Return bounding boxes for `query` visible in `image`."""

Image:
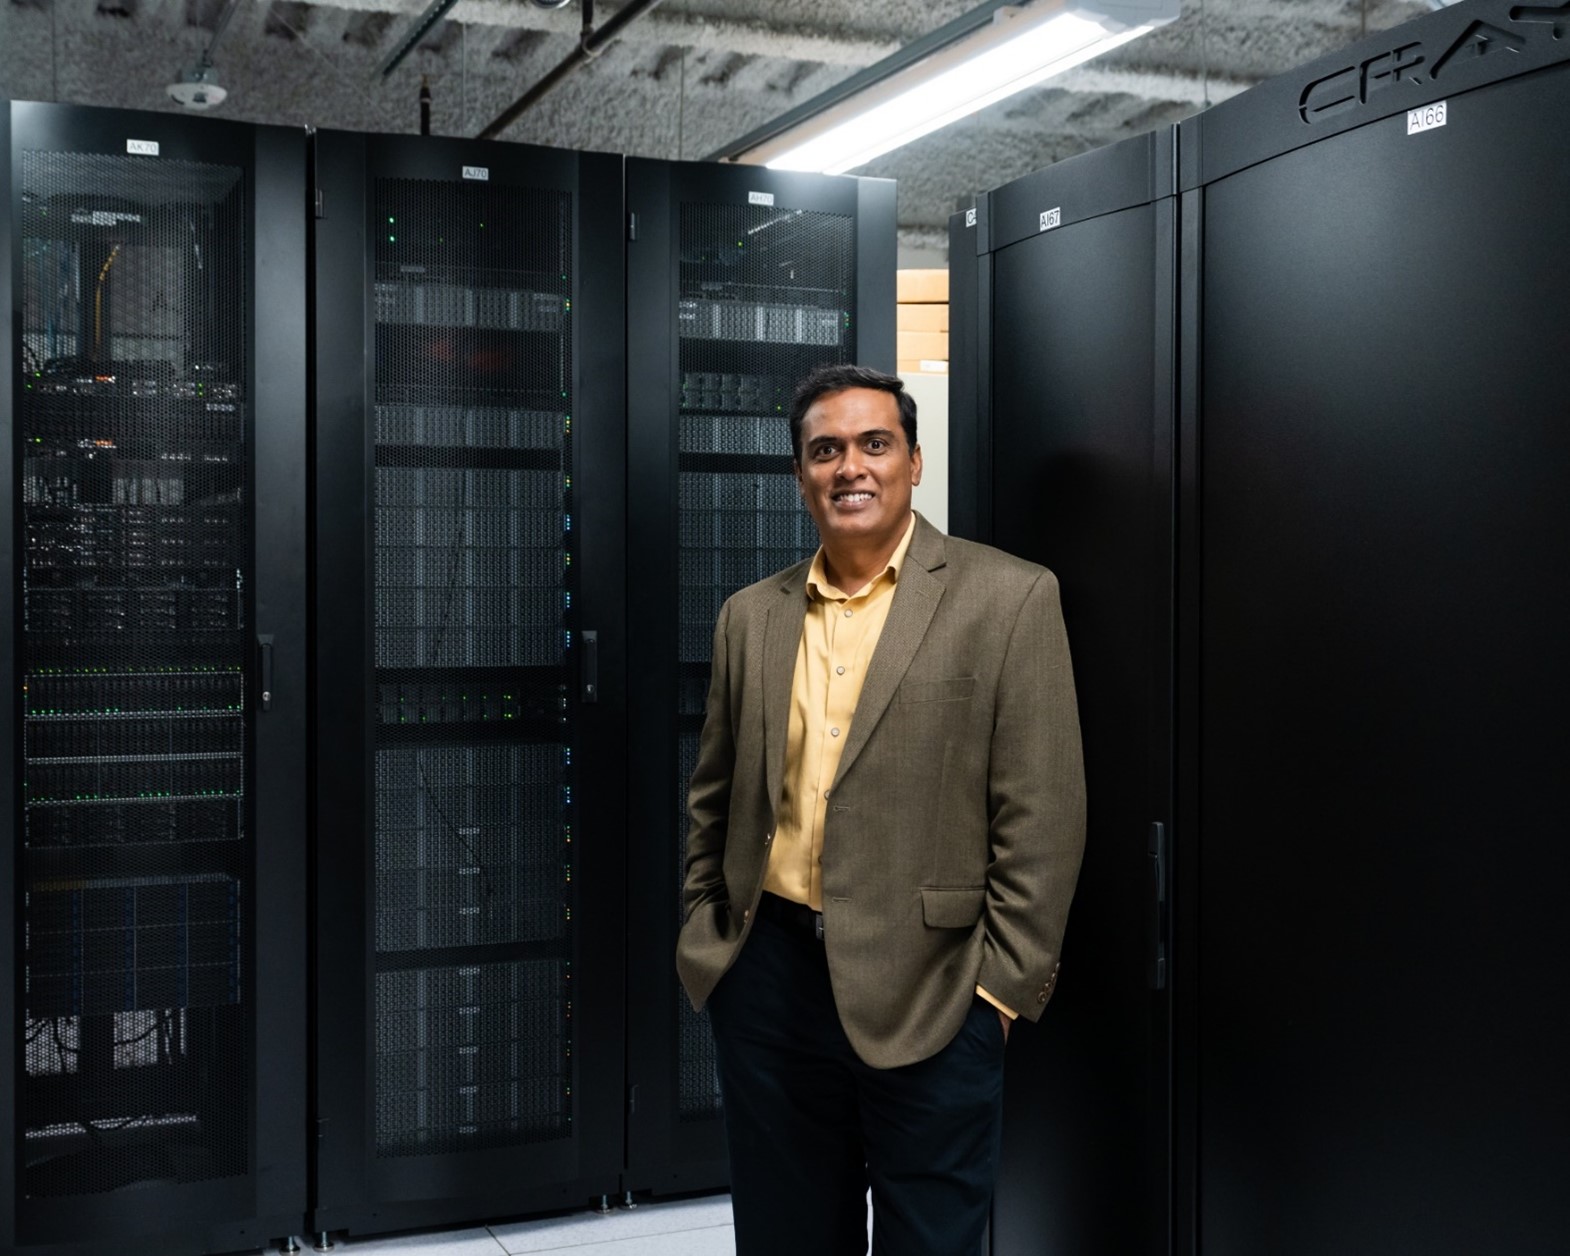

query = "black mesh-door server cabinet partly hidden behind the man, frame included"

[626,160,895,1192]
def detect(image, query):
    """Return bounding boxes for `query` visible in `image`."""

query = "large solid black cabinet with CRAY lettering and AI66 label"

[1179,0,1570,1256]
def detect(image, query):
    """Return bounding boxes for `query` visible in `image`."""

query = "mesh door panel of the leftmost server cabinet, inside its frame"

[16,149,254,1199]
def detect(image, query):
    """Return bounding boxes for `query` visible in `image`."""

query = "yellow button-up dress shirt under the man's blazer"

[763,515,1014,1017]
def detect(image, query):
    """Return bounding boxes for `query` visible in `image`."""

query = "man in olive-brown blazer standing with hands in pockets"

[677,357,1085,1256]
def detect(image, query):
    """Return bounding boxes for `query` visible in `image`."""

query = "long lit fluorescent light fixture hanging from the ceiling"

[713,0,1179,174]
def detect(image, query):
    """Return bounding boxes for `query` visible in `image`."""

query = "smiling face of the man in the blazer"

[796,388,922,551]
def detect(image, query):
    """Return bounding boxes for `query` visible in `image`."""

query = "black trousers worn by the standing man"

[708,917,1003,1256]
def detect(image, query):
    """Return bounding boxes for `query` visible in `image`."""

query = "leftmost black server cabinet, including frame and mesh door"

[0,104,308,1253]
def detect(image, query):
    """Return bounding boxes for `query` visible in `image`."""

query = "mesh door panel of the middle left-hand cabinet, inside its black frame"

[371,177,575,1159]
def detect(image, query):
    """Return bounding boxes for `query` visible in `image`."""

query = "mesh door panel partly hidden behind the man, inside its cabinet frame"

[670,204,856,1123]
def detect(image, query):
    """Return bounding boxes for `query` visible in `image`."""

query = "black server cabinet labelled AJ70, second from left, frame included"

[311,132,625,1232]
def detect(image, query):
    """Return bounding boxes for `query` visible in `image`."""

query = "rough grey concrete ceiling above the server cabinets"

[0,0,1433,265]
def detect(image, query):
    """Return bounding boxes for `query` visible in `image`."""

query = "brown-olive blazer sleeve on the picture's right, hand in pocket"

[977,571,1085,1021]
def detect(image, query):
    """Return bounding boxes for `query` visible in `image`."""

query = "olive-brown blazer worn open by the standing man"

[677,515,1085,1068]
